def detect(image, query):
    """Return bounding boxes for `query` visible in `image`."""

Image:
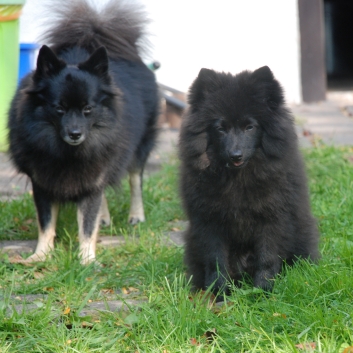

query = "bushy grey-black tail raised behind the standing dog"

[41,0,148,61]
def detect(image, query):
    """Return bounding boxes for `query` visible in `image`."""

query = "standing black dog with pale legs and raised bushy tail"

[9,0,158,263]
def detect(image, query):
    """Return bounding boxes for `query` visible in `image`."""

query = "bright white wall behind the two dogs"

[21,0,301,103]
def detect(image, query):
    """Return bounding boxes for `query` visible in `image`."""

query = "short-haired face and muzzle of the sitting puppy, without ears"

[209,116,261,169]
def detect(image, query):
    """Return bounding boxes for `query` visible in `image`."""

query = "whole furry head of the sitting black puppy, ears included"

[181,67,286,170]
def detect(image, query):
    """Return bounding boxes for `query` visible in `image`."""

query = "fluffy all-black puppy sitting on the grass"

[179,66,319,293]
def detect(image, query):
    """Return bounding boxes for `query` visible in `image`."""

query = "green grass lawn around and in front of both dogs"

[0,146,353,353]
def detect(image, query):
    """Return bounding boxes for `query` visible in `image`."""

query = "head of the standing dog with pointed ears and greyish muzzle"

[27,46,117,146]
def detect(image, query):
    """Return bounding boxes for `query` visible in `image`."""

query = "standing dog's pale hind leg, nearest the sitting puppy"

[129,170,145,224]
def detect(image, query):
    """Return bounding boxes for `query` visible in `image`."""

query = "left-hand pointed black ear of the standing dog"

[34,45,66,78]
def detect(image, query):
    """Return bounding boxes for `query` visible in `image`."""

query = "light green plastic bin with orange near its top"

[0,0,25,151]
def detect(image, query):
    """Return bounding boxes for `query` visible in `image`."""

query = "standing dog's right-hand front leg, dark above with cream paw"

[77,191,103,265]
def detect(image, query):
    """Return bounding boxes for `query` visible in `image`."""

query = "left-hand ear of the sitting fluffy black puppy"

[188,68,220,106]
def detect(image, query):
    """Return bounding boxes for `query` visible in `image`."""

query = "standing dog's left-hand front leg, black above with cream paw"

[25,183,59,262]
